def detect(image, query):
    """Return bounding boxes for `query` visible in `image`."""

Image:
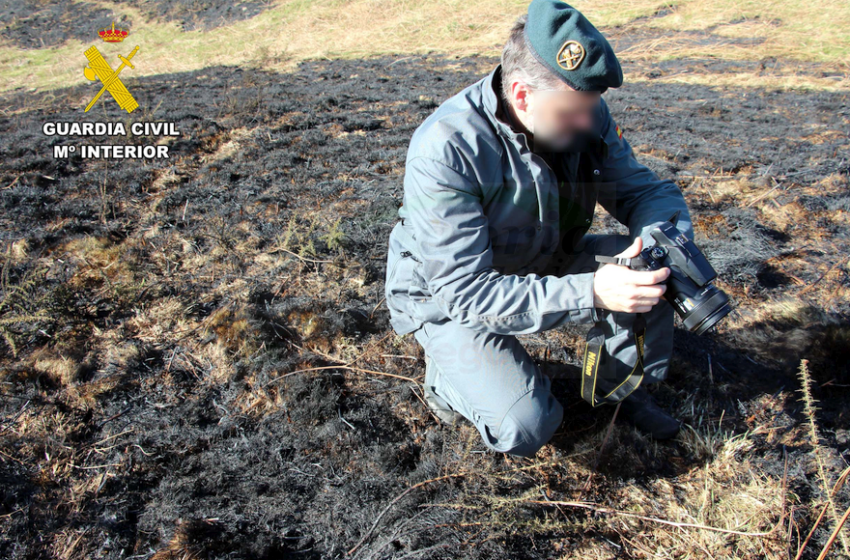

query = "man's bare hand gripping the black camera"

[593,237,670,313]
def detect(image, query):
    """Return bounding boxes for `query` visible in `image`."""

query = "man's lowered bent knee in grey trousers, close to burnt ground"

[499,384,564,457]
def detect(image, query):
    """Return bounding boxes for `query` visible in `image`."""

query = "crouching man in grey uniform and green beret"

[385,0,693,457]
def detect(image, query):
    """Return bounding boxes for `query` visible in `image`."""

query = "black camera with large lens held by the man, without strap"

[628,222,732,334]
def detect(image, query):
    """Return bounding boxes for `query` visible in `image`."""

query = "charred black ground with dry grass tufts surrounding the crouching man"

[0,49,850,560]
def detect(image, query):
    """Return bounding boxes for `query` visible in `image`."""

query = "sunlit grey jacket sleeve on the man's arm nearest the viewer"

[404,156,598,335]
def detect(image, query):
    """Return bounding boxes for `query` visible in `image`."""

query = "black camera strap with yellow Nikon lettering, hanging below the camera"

[581,313,646,407]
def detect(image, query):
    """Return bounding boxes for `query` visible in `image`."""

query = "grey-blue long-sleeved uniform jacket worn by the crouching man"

[385,65,693,335]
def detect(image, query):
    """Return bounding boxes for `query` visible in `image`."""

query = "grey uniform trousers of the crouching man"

[413,235,674,457]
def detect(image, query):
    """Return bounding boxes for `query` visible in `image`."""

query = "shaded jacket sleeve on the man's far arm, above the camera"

[599,100,694,247]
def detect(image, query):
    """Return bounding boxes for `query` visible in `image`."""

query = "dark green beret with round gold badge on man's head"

[524,0,623,92]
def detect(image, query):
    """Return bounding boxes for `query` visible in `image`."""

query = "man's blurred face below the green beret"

[506,81,602,151]
